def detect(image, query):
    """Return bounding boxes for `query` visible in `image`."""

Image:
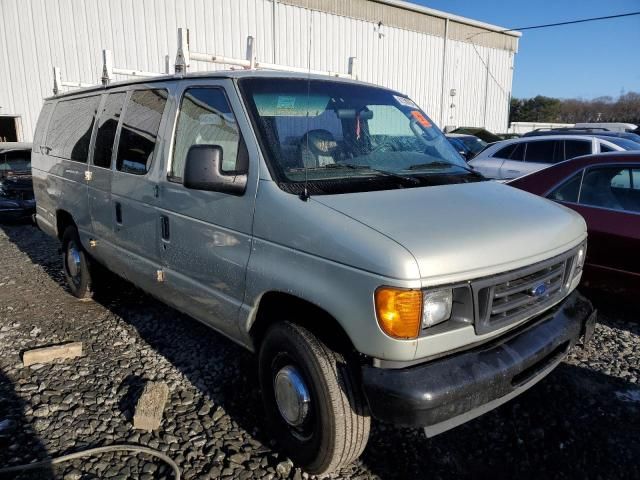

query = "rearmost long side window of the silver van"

[46,95,100,163]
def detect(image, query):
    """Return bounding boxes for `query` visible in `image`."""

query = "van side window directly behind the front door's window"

[116,89,167,175]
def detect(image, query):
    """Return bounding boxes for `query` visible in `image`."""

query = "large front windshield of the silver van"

[240,78,483,194]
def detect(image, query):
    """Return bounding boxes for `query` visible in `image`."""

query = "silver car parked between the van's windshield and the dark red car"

[469,135,635,180]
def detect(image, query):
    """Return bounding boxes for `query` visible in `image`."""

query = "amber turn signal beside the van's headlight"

[375,287,422,338]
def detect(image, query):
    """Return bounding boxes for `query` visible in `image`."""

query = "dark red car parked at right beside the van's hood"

[508,152,640,294]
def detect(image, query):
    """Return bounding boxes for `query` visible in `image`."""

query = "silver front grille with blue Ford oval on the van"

[472,251,575,334]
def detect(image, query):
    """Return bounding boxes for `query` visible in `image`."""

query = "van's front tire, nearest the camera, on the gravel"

[259,322,371,475]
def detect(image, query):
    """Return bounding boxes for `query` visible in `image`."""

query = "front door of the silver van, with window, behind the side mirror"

[158,80,258,336]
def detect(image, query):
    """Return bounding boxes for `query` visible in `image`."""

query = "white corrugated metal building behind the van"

[0,0,520,141]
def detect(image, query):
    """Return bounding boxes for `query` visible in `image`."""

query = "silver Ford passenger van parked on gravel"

[32,70,595,474]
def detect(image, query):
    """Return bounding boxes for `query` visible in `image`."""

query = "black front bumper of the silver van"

[362,291,597,436]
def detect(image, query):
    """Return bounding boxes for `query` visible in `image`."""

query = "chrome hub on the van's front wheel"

[273,365,311,427]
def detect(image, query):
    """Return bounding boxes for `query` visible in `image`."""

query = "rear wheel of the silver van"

[62,226,93,300]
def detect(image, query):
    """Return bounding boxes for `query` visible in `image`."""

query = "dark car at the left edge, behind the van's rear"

[0,142,35,220]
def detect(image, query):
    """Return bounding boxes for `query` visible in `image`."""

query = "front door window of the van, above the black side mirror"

[168,87,245,182]
